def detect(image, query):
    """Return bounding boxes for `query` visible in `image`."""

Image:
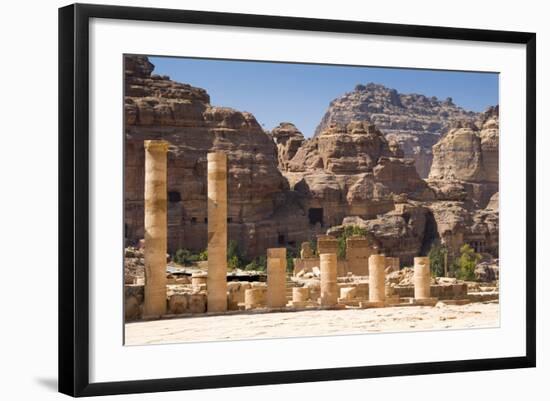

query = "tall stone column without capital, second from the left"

[206,152,227,312]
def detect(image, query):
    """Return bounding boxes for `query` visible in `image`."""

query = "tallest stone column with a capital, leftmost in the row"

[143,140,168,317]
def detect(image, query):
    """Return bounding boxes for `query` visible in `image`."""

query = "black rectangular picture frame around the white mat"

[59,4,536,396]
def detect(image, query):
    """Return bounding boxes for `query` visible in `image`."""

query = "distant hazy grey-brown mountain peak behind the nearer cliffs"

[315,83,480,178]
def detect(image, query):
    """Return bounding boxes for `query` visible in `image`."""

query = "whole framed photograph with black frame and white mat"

[59,4,536,396]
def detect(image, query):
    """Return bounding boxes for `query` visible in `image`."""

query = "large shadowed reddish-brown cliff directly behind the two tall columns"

[125,56,308,256]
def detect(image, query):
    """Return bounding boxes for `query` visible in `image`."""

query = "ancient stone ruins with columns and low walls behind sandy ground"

[125,146,498,320]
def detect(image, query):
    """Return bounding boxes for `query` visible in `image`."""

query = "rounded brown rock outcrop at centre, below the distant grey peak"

[284,121,434,230]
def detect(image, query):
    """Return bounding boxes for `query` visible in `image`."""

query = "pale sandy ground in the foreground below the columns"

[125,303,499,345]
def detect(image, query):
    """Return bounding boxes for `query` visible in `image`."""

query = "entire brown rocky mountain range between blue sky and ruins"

[124,56,498,263]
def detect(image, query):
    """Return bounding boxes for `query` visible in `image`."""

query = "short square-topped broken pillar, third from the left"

[267,248,286,308]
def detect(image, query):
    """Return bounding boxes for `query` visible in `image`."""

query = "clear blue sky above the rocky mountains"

[149,57,498,137]
